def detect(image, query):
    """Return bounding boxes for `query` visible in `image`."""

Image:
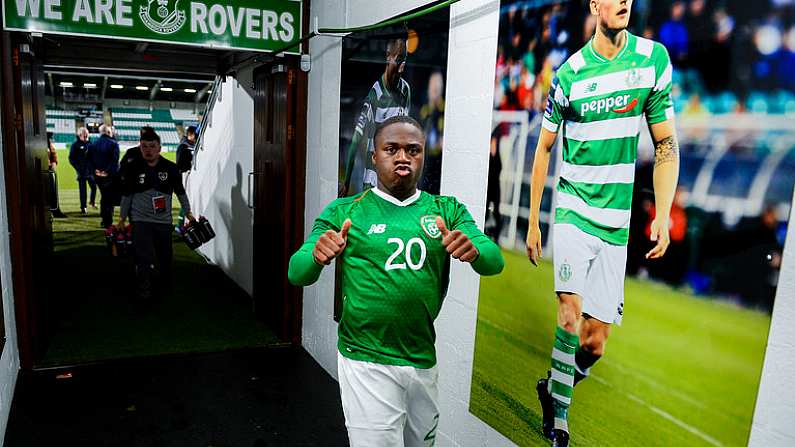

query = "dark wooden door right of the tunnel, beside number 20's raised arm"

[250,63,306,344]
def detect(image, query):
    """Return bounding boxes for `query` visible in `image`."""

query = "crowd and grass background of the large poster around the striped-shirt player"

[470,0,795,446]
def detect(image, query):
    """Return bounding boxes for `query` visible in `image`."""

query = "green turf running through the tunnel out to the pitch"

[41,151,277,366]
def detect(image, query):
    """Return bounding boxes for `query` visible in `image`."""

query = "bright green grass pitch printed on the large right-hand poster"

[470,252,770,446]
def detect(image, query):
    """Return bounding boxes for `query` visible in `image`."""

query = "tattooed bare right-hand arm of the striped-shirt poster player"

[646,119,679,259]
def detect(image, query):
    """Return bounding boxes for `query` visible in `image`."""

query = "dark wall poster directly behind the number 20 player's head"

[335,8,450,317]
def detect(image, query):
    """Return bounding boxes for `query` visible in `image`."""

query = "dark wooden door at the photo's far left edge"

[2,32,57,368]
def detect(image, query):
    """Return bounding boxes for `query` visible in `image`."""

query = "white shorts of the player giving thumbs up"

[337,352,439,447]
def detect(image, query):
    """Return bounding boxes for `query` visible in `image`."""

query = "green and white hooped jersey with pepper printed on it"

[542,32,674,245]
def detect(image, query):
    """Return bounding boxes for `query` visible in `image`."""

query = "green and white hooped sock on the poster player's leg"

[549,326,579,432]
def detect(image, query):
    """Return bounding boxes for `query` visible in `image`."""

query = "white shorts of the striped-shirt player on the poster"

[552,224,627,325]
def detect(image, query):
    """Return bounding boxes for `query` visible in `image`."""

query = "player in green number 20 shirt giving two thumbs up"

[288,116,504,447]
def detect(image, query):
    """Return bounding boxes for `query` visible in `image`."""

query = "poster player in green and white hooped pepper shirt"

[527,0,679,446]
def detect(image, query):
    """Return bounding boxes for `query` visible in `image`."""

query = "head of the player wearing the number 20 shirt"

[373,123,425,197]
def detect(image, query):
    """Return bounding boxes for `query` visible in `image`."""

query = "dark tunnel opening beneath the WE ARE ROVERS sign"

[2,26,307,370]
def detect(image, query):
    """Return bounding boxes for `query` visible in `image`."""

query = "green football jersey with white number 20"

[289,189,503,368]
